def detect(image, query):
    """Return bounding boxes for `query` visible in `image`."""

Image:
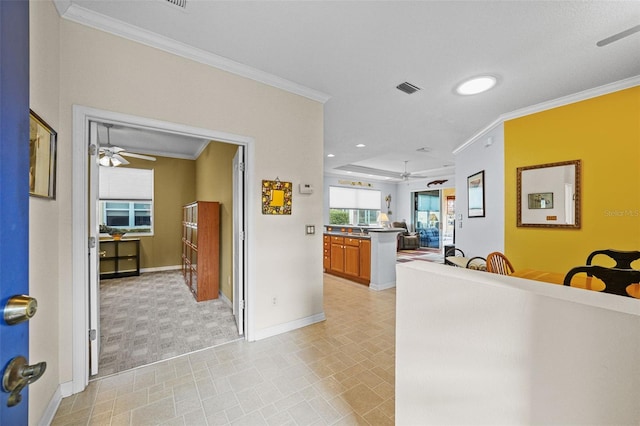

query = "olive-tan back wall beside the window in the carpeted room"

[114,156,196,268]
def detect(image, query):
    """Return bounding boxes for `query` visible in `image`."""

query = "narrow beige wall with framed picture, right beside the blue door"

[29,2,60,425]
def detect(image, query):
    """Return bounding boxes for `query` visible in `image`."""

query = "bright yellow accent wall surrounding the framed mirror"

[504,87,640,272]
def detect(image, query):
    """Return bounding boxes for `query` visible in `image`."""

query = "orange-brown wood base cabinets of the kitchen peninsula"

[322,235,371,285]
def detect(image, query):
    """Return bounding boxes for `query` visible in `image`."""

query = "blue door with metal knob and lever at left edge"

[0,0,29,425]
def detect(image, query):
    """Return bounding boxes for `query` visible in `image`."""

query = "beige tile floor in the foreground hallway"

[52,275,395,426]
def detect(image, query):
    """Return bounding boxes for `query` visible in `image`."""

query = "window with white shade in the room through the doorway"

[99,167,153,235]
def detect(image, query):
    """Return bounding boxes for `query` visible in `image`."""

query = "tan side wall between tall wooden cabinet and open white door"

[196,143,238,300]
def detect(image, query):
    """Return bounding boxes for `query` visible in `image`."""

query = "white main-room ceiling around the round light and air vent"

[55,0,640,180]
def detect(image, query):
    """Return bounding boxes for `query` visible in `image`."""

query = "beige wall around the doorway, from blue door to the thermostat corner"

[30,2,323,414]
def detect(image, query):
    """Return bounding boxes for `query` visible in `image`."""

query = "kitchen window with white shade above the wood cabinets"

[329,186,382,226]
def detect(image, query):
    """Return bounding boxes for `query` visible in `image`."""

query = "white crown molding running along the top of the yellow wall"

[453,75,640,155]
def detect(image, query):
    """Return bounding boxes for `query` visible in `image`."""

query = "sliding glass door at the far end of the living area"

[413,190,441,249]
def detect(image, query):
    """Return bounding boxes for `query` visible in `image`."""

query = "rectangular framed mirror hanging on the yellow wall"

[517,160,581,228]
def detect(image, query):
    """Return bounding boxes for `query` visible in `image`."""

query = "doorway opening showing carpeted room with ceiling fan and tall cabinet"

[89,121,243,379]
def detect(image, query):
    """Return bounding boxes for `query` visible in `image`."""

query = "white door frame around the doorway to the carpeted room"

[71,106,253,393]
